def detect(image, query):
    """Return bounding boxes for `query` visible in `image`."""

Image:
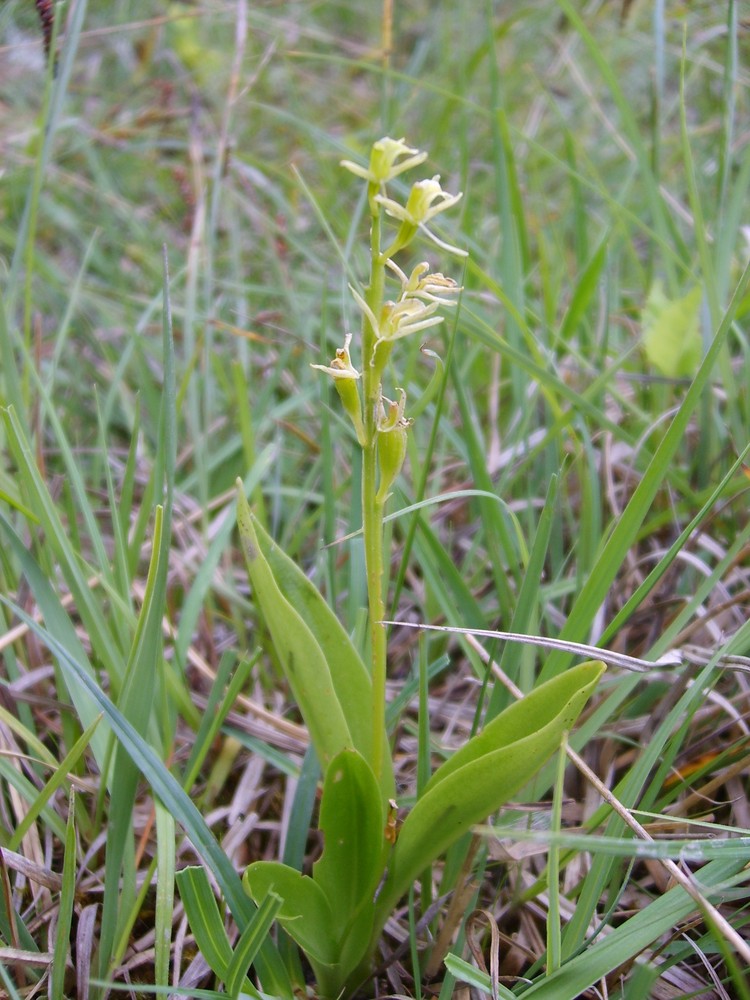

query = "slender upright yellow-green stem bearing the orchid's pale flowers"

[362,209,388,783]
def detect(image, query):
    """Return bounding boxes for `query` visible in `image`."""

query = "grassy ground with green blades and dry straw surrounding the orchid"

[0,0,750,1000]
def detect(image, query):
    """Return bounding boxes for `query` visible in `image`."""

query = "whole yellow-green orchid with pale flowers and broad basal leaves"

[229,138,604,1000]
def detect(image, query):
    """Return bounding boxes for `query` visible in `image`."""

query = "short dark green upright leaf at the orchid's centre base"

[313,750,387,944]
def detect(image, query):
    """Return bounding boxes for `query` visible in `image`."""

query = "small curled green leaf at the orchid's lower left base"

[242,861,338,966]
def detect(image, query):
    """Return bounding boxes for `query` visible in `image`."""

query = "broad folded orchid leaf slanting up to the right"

[376,661,605,926]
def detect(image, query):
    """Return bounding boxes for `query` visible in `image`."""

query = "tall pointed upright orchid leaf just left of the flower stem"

[243,494,394,799]
